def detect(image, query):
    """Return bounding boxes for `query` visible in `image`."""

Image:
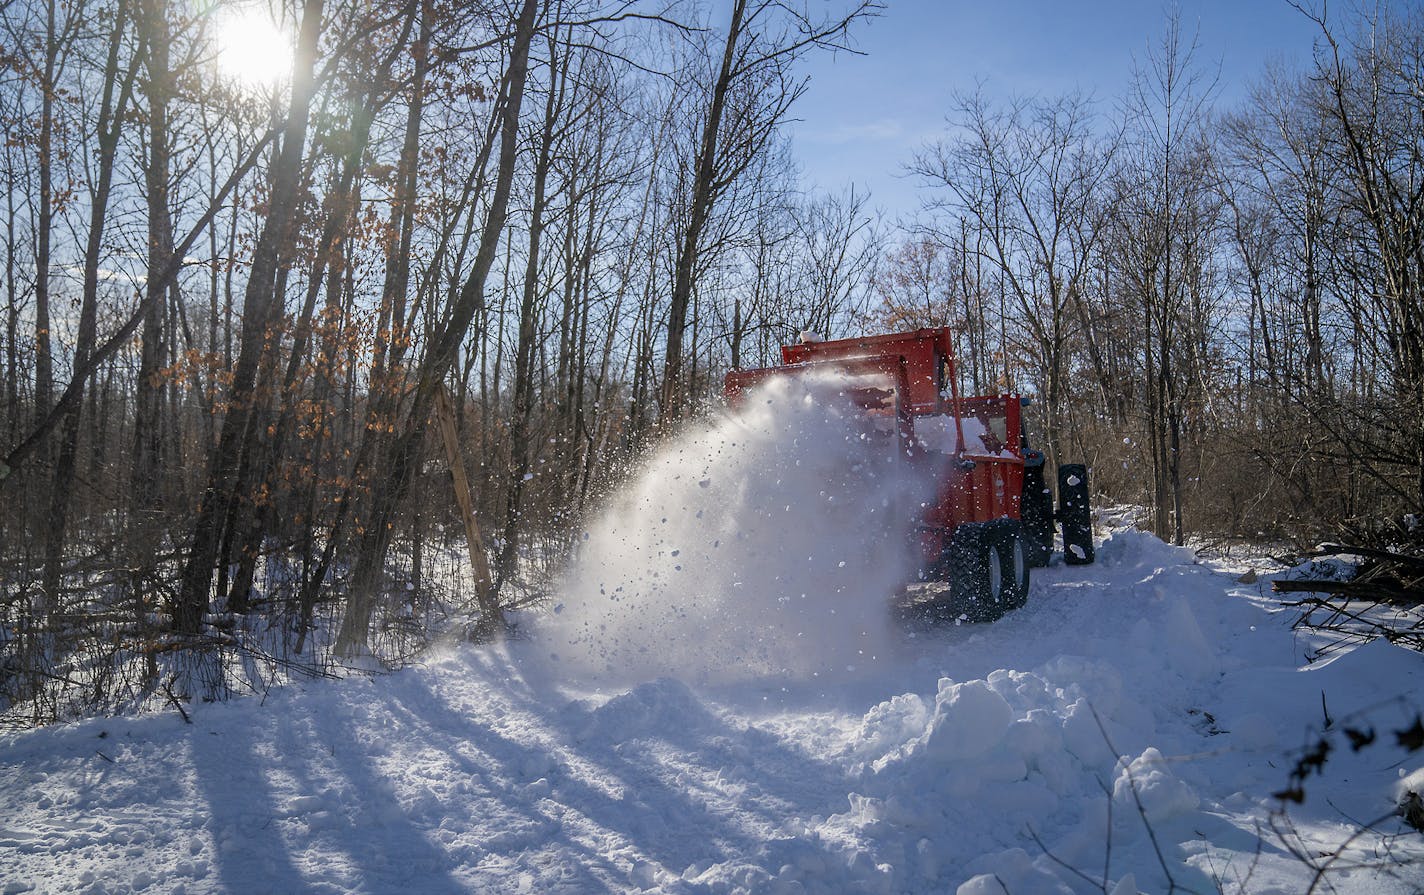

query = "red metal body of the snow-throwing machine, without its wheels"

[725,327,1024,565]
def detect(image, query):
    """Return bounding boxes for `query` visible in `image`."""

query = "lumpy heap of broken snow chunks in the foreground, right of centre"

[827,660,1218,892]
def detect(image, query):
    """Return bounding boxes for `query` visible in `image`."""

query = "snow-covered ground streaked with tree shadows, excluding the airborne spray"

[0,529,1424,895]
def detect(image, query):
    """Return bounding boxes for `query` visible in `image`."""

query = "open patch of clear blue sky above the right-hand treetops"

[792,0,1319,218]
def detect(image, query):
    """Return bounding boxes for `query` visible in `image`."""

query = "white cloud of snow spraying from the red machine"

[535,374,918,683]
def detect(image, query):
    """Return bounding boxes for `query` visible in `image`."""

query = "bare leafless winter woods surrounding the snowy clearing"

[0,0,1424,724]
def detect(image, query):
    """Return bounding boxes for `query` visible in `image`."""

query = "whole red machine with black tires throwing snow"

[725,327,1094,620]
